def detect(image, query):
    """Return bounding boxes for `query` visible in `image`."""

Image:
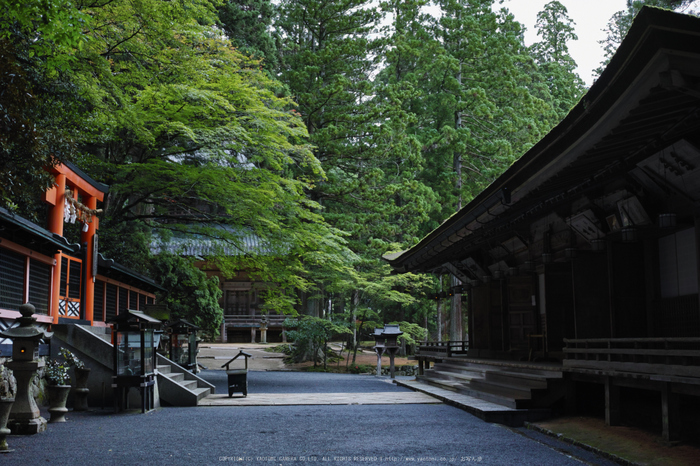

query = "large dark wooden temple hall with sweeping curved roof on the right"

[385,7,700,440]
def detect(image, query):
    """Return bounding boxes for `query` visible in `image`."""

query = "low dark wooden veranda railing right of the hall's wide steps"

[563,338,700,383]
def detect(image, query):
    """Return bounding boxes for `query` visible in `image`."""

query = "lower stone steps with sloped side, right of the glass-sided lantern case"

[156,354,216,406]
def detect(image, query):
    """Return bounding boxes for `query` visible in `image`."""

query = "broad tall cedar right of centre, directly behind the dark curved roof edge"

[417,0,555,228]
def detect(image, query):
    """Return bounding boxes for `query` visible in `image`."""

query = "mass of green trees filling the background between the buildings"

[0,0,640,345]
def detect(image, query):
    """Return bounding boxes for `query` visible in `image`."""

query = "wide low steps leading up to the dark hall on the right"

[416,357,565,424]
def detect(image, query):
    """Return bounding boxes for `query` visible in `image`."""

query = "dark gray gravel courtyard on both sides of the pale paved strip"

[0,371,609,466]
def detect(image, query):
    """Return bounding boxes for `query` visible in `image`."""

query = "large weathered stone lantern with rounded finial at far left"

[0,303,53,435]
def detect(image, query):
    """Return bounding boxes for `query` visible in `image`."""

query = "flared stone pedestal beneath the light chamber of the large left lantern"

[7,360,46,435]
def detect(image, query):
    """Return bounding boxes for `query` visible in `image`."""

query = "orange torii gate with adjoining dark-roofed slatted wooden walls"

[0,163,159,327]
